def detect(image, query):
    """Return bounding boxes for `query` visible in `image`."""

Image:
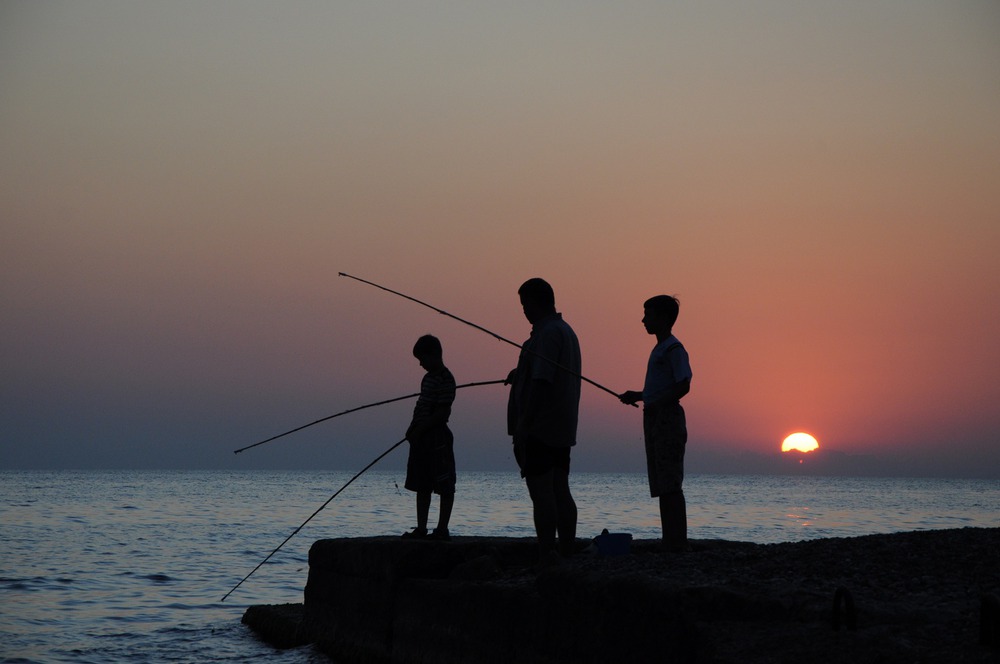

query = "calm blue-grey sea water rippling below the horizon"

[0,470,1000,663]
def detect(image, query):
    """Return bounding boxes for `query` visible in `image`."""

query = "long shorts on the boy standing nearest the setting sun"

[642,401,687,498]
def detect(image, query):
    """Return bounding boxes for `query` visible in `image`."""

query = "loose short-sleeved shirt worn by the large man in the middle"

[507,313,581,447]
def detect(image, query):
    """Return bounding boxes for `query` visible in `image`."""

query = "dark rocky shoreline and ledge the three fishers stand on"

[243,528,1000,664]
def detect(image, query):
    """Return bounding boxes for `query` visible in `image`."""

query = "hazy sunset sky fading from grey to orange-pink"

[0,0,1000,478]
